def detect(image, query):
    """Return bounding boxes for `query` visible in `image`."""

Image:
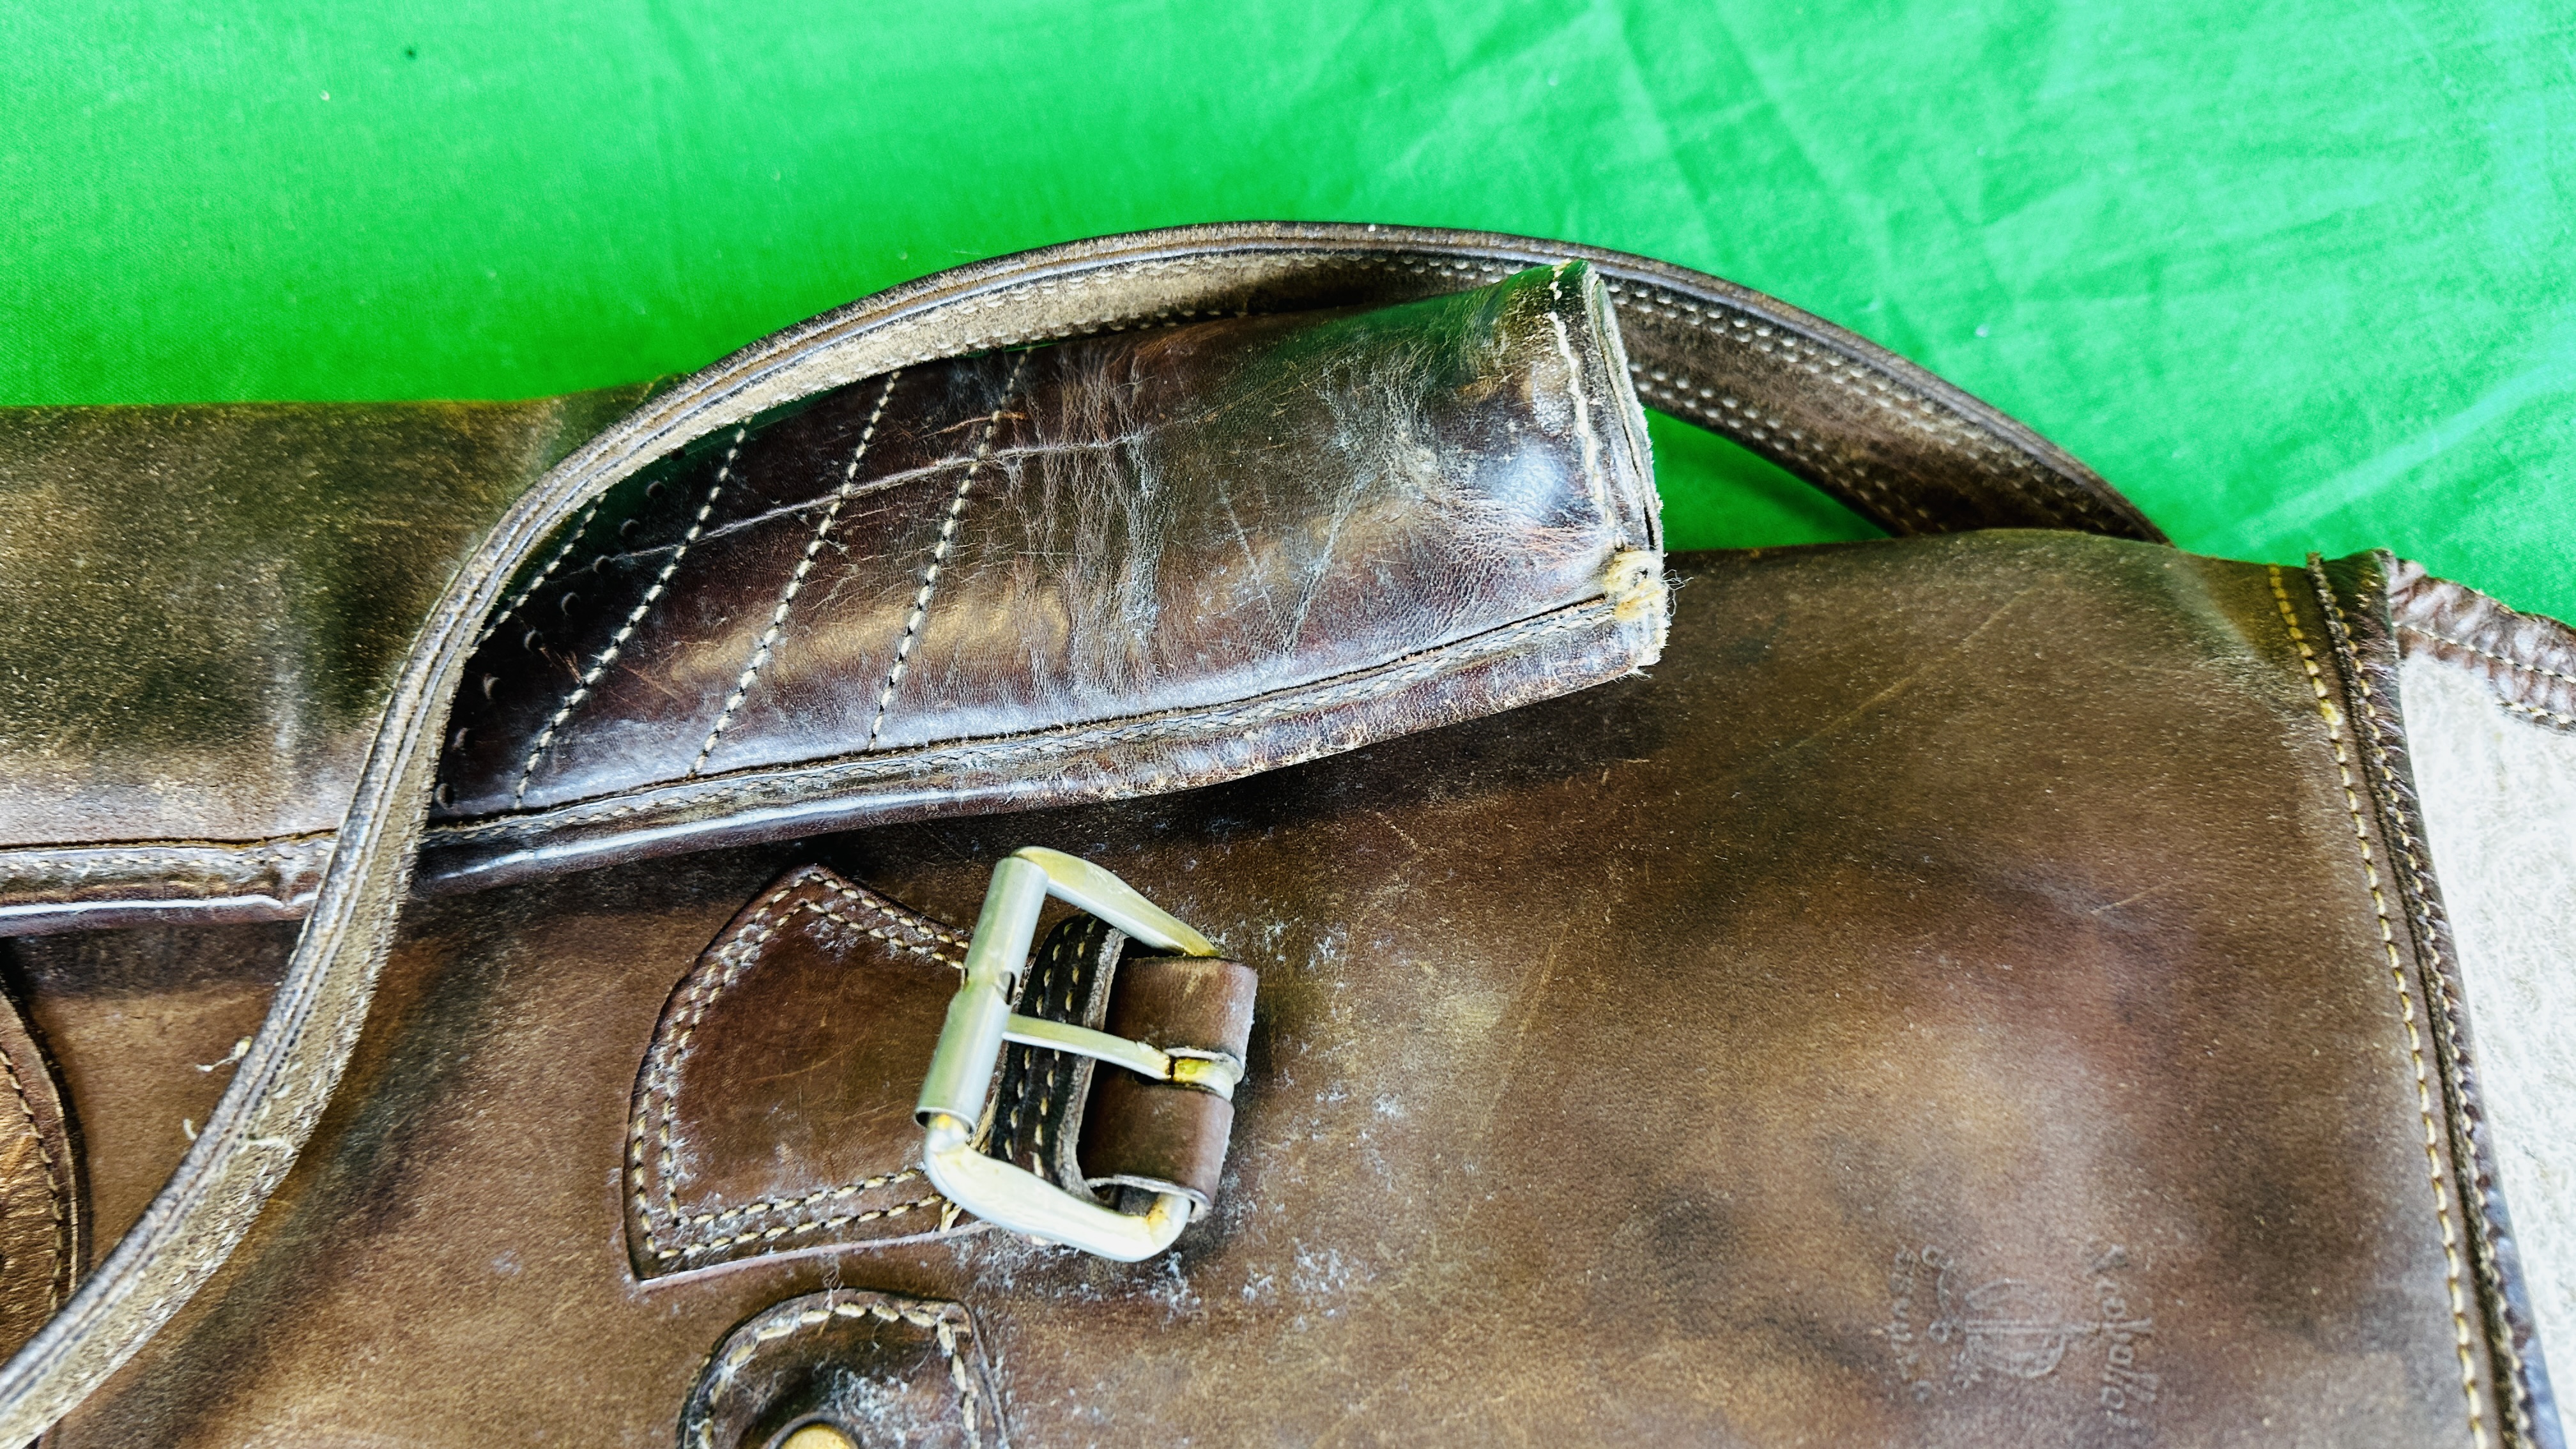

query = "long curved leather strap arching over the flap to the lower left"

[0,222,2159,1444]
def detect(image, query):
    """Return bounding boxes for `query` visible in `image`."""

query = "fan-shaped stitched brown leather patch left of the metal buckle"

[626,866,966,1279]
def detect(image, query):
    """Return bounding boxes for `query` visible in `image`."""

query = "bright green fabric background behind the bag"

[0,0,2576,617]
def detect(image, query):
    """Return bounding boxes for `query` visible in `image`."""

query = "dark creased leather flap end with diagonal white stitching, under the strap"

[422,263,1664,884]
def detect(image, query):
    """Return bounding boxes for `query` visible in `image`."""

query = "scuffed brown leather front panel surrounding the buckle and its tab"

[35,533,2506,1446]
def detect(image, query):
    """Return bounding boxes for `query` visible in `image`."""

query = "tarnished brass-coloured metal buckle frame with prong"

[912,846,1239,1263]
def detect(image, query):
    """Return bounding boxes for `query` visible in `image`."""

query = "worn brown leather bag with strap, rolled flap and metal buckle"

[0,224,2576,1449]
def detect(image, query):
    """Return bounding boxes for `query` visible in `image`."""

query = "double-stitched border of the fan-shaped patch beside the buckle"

[626,866,958,1263]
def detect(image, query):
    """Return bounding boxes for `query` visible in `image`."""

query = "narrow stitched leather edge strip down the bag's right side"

[2306,552,2566,1449]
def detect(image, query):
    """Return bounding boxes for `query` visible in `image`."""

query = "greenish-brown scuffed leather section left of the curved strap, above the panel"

[0,387,644,933]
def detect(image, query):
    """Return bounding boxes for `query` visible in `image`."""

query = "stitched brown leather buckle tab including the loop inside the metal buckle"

[624,866,1257,1282]
